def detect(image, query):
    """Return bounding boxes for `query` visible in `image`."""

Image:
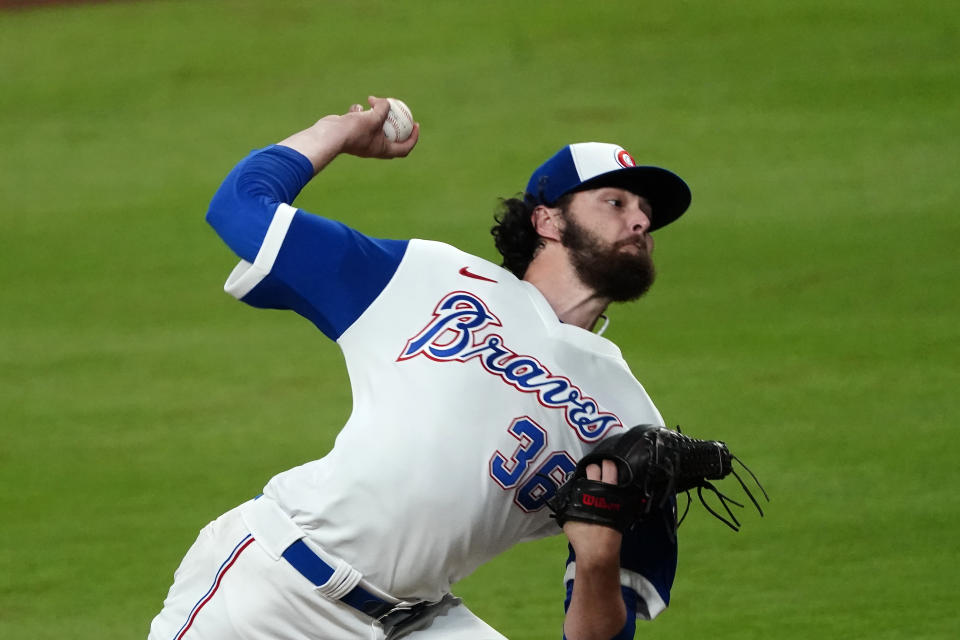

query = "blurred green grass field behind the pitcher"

[0,0,960,640]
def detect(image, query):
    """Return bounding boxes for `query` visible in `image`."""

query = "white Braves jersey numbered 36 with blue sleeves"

[208,147,676,617]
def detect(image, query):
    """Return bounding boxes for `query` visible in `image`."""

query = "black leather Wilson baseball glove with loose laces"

[547,425,769,531]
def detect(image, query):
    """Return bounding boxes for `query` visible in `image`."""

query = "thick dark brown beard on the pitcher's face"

[560,211,656,302]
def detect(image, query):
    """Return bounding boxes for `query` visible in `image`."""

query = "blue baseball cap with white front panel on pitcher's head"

[526,142,691,231]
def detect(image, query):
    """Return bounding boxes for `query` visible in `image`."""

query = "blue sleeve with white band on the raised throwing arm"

[207,145,408,340]
